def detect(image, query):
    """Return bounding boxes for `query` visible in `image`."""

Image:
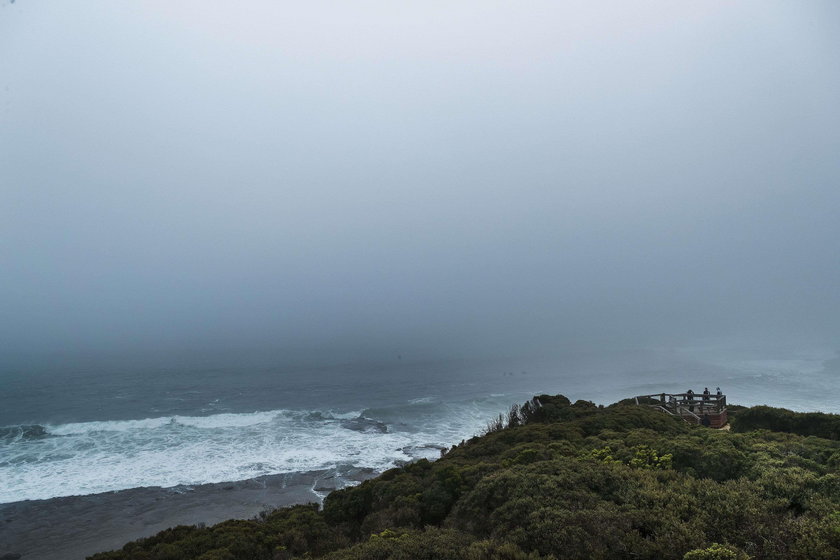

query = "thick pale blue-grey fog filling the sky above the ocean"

[0,0,840,367]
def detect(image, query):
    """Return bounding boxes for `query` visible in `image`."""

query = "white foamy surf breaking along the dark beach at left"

[0,401,508,503]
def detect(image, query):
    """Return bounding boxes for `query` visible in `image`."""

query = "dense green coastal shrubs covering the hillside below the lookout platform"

[87,395,840,560]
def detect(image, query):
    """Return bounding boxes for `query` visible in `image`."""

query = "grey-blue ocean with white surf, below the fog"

[0,347,840,503]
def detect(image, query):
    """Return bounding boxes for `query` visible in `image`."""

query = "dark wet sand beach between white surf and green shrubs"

[0,469,376,560]
